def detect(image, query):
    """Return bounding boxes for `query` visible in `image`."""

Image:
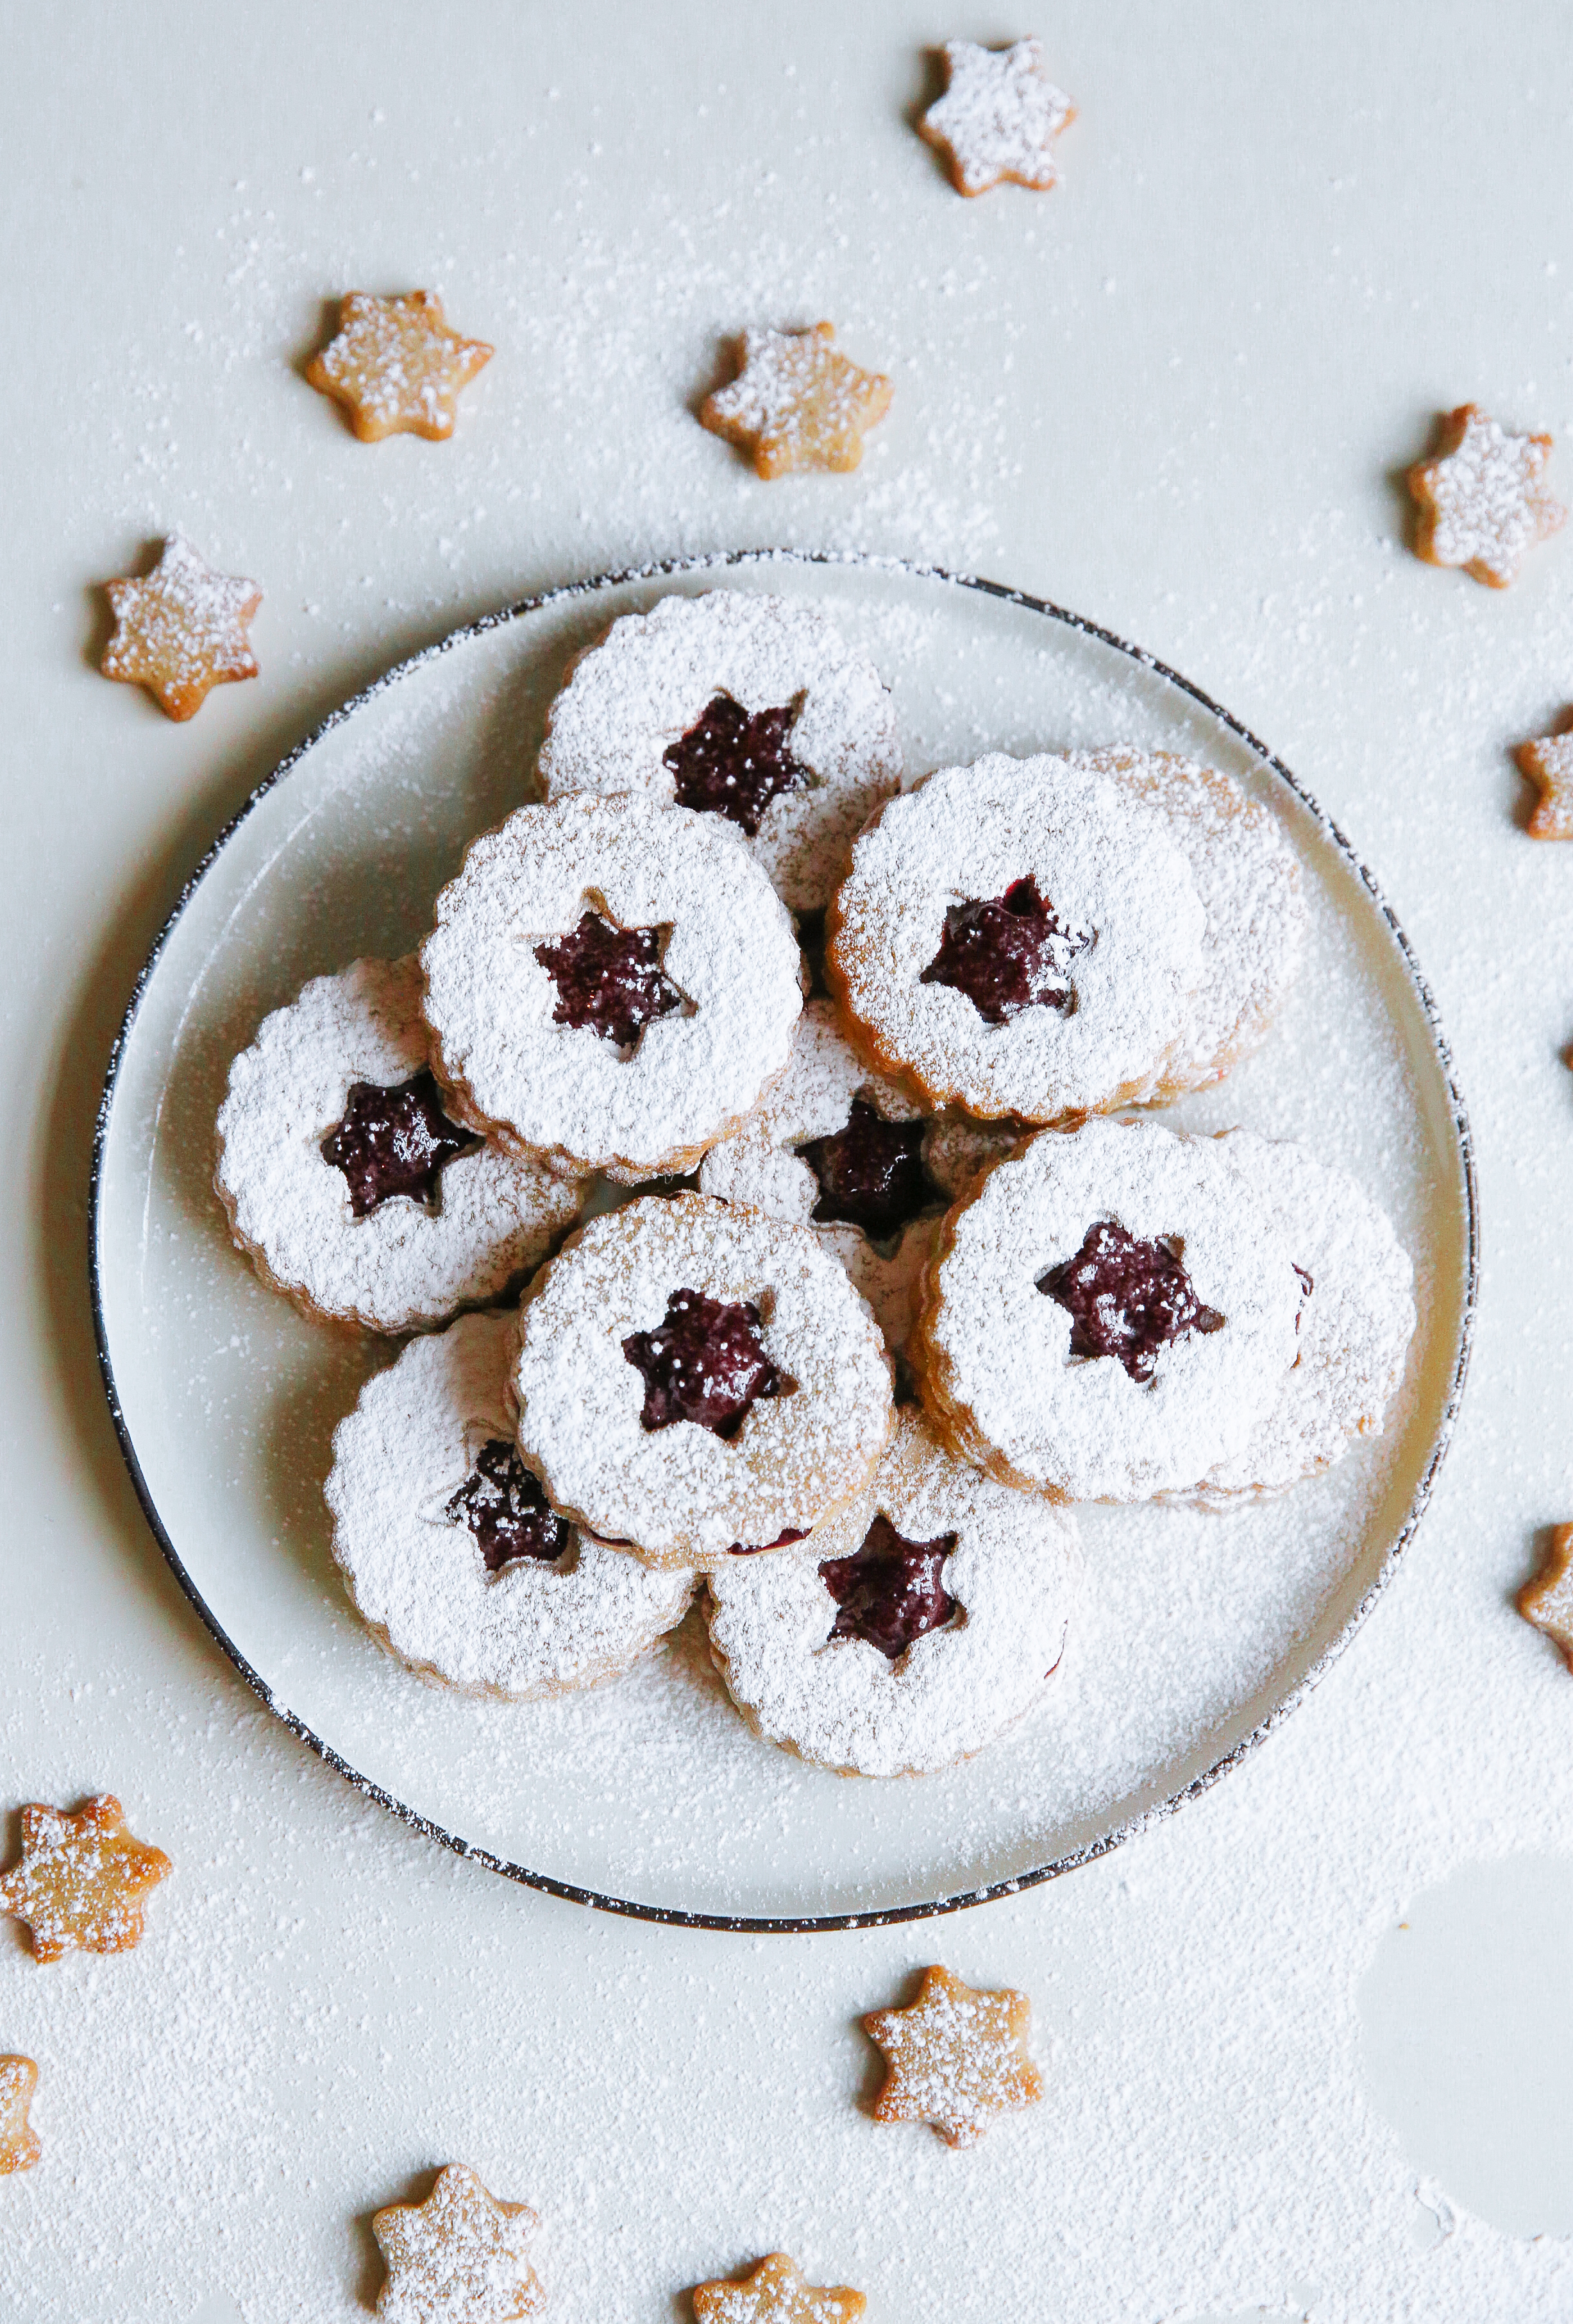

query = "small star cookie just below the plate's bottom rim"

[862,1969,1043,2148]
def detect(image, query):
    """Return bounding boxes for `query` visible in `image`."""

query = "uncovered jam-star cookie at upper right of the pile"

[825,753,1206,1123]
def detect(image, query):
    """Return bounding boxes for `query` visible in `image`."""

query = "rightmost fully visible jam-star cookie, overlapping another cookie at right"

[913,1120,1301,1501]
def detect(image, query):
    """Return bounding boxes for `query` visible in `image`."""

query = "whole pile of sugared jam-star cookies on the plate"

[216,590,1415,1776]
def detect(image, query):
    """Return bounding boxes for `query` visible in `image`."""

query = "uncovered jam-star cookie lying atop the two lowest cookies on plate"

[514,1194,892,1566]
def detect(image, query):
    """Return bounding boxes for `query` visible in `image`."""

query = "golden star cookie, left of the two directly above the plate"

[307,291,492,444]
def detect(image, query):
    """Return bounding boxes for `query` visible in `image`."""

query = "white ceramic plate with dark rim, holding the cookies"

[93,556,1476,1929]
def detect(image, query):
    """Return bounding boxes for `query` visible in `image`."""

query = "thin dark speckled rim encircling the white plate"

[88,548,1480,1936]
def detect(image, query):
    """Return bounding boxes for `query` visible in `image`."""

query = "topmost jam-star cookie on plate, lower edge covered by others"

[541,588,902,911]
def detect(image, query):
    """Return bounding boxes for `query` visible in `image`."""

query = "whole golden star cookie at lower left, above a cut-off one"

[0,1792,174,1962]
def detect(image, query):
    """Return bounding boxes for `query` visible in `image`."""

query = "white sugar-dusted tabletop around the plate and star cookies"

[0,0,1573,2324]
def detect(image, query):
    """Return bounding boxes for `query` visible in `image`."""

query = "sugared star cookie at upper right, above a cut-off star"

[1408,404,1569,588]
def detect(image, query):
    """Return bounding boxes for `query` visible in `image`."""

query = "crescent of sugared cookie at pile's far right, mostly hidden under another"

[1194,1130,1415,1506]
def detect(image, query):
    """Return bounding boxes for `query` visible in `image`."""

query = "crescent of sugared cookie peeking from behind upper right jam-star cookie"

[1069,746,1306,1101]
